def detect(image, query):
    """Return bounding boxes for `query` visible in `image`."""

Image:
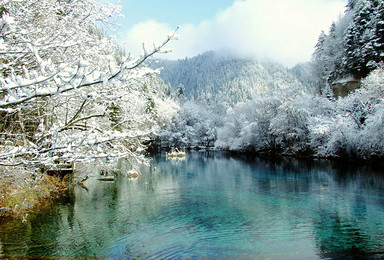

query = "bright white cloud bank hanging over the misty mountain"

[126,0,346,66]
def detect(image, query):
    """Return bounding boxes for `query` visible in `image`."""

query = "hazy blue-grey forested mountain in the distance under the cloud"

[152,51,304,105]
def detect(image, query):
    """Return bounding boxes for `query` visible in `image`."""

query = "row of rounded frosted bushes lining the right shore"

[216,67,384,159]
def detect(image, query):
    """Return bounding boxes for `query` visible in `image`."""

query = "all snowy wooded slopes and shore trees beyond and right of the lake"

[160,0,384,159]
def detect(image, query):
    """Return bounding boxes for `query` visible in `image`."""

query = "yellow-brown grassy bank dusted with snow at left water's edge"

[0,167,69,221]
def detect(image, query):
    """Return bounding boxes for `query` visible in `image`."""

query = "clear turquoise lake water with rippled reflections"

[0,152,384,259]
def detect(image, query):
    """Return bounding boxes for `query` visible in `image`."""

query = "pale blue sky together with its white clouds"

[109,0,347,67]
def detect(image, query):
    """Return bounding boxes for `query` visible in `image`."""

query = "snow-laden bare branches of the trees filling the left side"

[0,0,174,165]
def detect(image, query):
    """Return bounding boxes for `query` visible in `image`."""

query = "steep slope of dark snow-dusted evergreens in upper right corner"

[313,0,384,92]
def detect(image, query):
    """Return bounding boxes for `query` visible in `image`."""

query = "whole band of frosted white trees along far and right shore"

[158,66,384,160]
